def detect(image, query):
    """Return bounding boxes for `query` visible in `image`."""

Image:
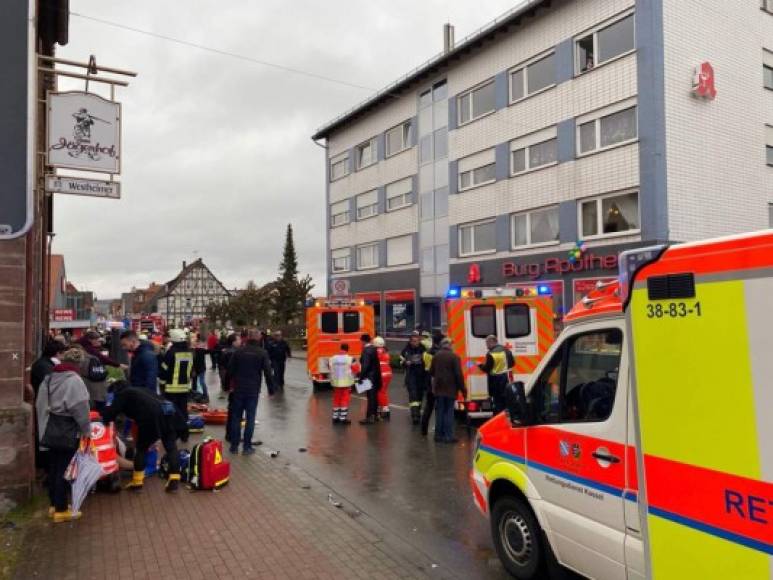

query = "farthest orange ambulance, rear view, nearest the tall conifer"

[306,298,376,390]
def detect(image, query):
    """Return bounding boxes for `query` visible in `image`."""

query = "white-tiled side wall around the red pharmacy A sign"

[664,0,773,240]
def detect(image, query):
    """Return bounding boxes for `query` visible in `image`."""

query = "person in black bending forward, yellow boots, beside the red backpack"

[102,381,187,492]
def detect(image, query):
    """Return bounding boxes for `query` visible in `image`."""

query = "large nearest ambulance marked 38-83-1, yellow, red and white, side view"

[471,230,773,580]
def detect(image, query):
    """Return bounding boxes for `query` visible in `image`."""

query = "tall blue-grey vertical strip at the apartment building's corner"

[635,0,669,241]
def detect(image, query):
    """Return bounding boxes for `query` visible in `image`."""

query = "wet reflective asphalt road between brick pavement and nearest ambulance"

[208,359,509,580]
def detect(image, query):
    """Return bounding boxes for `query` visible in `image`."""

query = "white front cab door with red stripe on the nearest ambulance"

[526,320,628,580]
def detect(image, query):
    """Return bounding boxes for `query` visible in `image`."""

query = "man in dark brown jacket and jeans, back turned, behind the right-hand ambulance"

[429,338,467,443]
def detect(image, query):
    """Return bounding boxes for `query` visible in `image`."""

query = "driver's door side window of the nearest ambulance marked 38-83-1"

[528,328,623,424]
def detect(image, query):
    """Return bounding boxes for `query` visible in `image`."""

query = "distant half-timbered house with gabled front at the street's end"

[153,258,231,328]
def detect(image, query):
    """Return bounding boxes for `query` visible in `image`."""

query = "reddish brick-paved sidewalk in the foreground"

[15,430,440,580]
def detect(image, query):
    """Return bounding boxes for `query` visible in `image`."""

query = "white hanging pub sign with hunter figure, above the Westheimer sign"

[47,92,121,174]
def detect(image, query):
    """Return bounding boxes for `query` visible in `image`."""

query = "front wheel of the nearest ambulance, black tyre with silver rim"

[491,496,545,580]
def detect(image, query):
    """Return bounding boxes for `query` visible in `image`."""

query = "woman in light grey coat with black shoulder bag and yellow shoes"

[35,349,91,523]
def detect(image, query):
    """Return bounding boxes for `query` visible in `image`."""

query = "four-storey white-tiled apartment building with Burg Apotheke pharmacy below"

[313,0,773,336]
